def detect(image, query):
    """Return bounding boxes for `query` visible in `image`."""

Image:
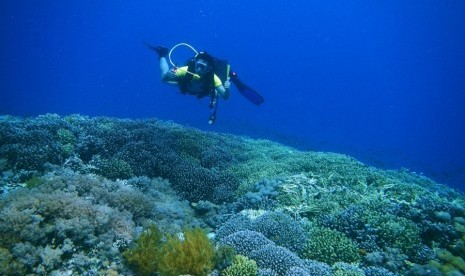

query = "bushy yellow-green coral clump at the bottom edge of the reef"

[124,226,215,276]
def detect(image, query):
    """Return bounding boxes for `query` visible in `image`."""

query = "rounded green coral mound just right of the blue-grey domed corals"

[302,227,361,265]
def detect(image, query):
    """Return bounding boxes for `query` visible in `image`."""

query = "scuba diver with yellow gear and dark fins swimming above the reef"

[145,43,264,124]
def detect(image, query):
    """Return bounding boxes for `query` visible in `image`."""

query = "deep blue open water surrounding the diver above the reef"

[0,0,465,190]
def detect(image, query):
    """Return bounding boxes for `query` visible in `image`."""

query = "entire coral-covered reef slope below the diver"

[0,114,465,275]
